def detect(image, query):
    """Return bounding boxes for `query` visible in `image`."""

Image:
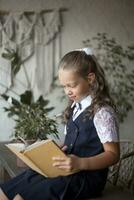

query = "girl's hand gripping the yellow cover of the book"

[52,155,81,172]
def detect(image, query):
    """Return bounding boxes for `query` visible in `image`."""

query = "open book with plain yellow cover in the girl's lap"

[6,139,74,177]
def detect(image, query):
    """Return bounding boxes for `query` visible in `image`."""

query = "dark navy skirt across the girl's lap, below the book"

[0,169,105,200]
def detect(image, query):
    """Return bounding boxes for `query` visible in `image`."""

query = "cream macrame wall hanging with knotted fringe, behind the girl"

[0,9,64,95]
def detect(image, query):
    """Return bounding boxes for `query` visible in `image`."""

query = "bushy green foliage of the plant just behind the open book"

[2,90,58,141]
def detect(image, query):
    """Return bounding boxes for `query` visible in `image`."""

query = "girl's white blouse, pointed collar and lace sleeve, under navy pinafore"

[65,96,119,143]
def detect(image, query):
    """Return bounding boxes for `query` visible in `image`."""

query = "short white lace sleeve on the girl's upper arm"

[94,107,119,143]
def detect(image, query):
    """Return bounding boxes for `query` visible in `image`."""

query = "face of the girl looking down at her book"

[59,69,93,102]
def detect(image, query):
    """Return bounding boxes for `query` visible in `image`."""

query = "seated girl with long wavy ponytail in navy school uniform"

[0,48,119,200]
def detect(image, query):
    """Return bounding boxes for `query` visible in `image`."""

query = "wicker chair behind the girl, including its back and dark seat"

[86,140,134,200]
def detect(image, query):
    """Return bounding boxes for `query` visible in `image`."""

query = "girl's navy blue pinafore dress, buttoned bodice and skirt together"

[0,111,108,200]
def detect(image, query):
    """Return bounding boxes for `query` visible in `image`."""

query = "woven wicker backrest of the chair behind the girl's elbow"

[108,140,134,195]
